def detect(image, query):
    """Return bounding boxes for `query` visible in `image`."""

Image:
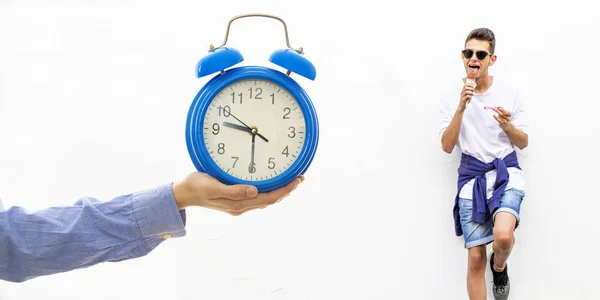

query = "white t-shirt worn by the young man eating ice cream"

[439,77,528,199]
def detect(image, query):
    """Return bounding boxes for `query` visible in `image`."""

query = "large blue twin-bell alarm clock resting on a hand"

[186,14,319,192]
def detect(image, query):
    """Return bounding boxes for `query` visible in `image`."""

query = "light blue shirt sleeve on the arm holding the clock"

[0,183,186,282]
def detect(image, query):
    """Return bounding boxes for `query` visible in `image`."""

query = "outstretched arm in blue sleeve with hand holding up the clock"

[0,173,304,282]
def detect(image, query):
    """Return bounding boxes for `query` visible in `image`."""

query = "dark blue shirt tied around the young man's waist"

[454,151,521,236]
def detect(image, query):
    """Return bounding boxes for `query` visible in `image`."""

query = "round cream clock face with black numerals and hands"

[203,79,306,181]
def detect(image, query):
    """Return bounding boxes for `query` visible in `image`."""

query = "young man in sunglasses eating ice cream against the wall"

[440,28,528,300]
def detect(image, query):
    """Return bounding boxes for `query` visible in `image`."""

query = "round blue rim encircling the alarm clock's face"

[186,66,319,192]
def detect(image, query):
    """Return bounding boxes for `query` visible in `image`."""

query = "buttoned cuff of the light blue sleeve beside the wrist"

[132,183,186,239]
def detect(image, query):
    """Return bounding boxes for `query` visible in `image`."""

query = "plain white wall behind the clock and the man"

[0,0,600,300]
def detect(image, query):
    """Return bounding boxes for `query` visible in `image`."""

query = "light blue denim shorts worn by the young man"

[458,189,525,249]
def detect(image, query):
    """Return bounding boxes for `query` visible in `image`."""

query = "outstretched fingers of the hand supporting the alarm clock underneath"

[212,176,304,216]
